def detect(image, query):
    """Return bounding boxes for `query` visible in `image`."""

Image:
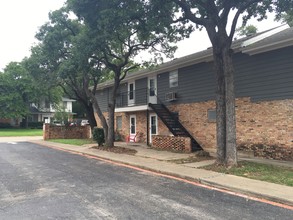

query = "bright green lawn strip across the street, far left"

[0,128,43,137]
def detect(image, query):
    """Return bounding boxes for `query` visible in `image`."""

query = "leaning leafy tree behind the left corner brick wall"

[32,8,102,128]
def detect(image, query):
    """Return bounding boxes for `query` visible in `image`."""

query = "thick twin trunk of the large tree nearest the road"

[213,41,237,167]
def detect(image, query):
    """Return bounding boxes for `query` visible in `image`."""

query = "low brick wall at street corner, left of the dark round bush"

[43,124,91,140]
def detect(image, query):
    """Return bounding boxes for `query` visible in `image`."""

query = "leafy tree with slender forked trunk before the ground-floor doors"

[67,0,184,147]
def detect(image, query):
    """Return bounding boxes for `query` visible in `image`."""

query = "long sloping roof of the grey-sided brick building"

[98,25,293,89]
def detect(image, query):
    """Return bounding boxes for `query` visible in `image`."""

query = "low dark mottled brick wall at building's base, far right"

[238,144,293,161]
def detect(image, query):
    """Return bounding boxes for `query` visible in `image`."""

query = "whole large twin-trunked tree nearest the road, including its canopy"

[149,0,293,166]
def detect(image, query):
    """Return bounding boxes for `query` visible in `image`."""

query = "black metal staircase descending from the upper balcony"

[149,103,202,151]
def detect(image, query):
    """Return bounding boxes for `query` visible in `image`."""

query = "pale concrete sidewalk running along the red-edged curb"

[30,140,293,209]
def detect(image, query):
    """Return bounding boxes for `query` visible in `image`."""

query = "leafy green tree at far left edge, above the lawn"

[0,62,57,127]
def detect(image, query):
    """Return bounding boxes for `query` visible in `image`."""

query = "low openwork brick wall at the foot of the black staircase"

[152,135,191,152]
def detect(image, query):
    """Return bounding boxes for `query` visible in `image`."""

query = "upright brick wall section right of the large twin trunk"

[236,98,293,148]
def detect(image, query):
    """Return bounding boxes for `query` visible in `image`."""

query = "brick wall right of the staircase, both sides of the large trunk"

[169,98,293,148]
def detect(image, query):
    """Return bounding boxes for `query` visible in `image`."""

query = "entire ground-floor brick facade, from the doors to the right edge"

[94,98,293,160]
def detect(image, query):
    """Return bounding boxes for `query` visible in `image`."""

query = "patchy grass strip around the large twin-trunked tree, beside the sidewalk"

[202,161,293,186]
